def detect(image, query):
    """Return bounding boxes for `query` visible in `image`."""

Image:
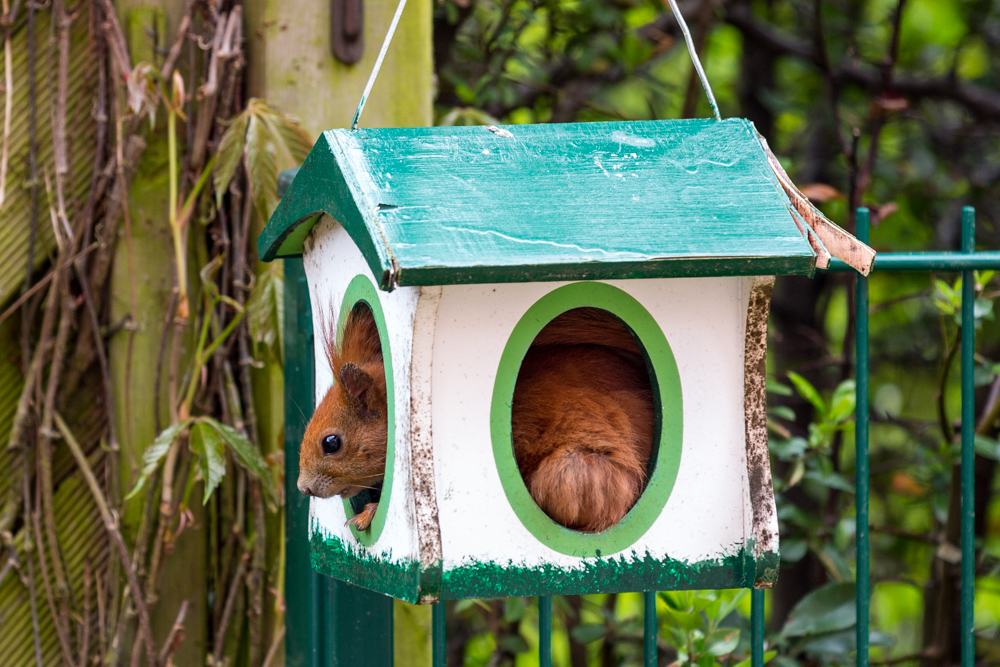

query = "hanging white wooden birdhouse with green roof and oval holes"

[258,119,874,602]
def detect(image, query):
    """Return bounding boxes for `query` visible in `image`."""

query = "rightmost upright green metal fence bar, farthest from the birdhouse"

[961,206,976,667]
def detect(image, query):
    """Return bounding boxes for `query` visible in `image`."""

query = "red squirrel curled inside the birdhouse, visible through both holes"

[298,307,655,532]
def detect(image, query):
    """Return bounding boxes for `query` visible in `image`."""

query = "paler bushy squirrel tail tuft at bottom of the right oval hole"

[528,441,646,532]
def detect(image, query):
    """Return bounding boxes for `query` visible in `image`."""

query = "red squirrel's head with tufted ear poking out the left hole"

[298,303,388,498]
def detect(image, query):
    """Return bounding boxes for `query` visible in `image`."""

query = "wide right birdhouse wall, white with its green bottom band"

[431,277,755,598]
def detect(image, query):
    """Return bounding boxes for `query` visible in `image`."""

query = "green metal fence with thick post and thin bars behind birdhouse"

[285,207,1000,667]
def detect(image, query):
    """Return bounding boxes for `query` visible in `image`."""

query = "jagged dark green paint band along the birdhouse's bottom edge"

[311,533,778,602]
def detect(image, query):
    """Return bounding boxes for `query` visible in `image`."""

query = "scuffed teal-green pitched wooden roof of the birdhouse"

[258,119,816,289]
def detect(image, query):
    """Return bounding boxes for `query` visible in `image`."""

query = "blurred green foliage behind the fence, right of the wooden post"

[434,0,1000,667]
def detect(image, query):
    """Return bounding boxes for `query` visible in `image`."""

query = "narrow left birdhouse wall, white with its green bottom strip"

[303,216,420,602]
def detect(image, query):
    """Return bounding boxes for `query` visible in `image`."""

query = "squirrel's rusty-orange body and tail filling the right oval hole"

[511,308,655,532]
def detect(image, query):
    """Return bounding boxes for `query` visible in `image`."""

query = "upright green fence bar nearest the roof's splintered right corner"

[854,208,869,667]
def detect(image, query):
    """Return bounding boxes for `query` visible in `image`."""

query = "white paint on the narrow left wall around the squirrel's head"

[303,216,420,561]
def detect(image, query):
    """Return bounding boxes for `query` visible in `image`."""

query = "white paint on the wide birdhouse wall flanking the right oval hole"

[433,278,753,570]
